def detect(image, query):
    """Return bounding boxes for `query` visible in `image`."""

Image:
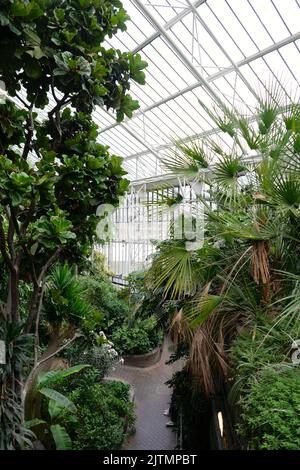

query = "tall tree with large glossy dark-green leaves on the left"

[0,0,147,444]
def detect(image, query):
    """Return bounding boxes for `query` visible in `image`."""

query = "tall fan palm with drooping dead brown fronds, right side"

[146,81,300,394]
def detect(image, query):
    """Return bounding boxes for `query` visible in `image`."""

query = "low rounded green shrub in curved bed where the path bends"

[112,317,163,354]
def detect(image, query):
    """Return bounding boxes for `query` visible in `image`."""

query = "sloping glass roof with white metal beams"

[98,0,300,181]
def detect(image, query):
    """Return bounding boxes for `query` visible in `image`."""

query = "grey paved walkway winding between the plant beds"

[110,339,181,450]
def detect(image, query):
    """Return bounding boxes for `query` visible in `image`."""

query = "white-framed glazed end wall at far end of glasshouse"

[96,179,205,277]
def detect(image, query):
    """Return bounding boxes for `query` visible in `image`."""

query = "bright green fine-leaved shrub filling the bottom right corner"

[239,366,300,450]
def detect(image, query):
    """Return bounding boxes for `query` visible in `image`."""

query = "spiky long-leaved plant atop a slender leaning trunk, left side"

[24,263,113,422]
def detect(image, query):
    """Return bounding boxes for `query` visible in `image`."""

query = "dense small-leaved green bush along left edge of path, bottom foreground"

[56,369,134,450]
